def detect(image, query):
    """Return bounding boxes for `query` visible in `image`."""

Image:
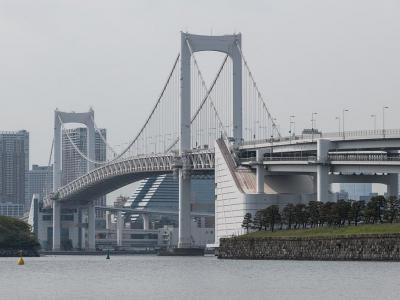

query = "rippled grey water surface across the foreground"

[0,255,400,300]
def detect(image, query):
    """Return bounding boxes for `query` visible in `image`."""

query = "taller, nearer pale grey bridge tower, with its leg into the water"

[178,32,242,248]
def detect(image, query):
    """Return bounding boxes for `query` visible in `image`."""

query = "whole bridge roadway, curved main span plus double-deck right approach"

[44,130,400,206]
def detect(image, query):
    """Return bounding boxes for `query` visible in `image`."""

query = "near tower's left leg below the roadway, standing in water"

[178,169,192,248]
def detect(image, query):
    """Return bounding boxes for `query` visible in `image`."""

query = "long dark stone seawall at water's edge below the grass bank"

[218,233,400,261]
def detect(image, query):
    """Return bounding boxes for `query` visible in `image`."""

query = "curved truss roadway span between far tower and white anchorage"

[44,150,214,207]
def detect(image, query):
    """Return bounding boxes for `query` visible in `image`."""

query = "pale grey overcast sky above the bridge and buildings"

[0,0,400,168]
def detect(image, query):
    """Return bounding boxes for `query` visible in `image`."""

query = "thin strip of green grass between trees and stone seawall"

[241,223,400,238]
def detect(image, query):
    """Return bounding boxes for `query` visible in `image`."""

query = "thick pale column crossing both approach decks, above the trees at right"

[317,139,330,202]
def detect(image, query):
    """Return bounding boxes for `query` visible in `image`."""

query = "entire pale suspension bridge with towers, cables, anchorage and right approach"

[44,32,400,250]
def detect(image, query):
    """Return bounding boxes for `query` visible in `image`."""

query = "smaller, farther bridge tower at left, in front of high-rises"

[53,109,95,251]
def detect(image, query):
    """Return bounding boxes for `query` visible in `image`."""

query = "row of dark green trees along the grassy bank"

[242,196,400,232]
